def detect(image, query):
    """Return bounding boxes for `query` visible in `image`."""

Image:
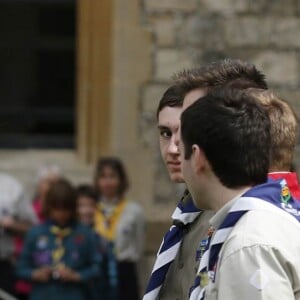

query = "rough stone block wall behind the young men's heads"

[139,0,300,216]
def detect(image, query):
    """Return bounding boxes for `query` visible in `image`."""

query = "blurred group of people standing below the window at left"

[0,157,145,300]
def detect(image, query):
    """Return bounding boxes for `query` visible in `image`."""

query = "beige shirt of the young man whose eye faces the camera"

[159,211,213,300]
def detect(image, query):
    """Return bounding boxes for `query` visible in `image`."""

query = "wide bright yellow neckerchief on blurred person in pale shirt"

[95,200,127,241]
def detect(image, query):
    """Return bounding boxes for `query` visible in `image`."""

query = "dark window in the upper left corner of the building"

[0,0,76,148]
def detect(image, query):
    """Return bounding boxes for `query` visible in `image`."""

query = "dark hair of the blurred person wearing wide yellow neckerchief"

[95,157,129,197]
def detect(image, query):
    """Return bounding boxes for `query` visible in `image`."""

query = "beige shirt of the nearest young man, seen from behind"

[205,200,300,300]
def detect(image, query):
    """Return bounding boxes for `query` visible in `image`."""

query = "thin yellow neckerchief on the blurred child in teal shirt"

[50,225,72,267]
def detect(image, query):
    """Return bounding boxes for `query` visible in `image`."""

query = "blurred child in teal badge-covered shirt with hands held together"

[17,179,99,300]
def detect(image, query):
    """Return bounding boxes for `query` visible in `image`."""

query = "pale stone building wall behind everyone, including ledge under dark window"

[0,0,300,290]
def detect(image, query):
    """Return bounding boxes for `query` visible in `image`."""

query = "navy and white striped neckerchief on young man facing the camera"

[143,191,202,300]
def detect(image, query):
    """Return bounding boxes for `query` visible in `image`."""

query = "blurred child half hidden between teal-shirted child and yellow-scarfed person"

[77,185,117,300]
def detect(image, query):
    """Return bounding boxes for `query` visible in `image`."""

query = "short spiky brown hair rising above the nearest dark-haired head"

[174,58,268,96]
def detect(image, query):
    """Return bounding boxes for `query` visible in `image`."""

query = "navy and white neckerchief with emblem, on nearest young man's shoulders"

[189,180,300,300]
